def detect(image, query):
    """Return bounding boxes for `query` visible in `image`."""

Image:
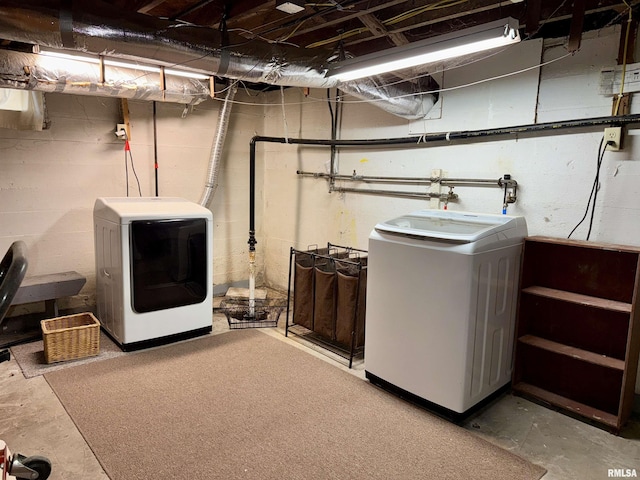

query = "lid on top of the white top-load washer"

[375,210,523,243]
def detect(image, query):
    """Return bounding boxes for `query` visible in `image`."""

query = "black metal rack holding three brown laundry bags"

[285,243,367,368]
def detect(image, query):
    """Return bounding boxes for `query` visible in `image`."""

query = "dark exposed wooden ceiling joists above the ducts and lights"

[0,0,640,75]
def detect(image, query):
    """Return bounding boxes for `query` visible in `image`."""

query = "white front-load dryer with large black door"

[93,197,213,350]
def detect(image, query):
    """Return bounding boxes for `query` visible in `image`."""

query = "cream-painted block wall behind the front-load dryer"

[0,93,263,315]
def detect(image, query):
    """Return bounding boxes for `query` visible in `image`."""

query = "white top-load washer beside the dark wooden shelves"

[365,210,527,414]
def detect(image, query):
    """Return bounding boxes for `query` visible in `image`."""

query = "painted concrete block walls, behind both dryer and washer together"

[0,27,640,391]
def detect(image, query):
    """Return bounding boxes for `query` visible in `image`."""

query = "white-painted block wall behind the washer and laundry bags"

[260,28,640,288]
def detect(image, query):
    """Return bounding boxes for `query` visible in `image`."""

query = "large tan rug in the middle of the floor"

[45,330,545,480]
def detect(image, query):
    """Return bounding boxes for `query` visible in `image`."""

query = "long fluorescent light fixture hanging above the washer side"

[327,17,520,82]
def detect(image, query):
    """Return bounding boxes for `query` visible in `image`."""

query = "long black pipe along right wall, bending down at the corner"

[248,114,640,251]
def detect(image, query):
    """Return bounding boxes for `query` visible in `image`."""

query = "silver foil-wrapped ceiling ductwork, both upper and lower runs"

[0,0,437,119]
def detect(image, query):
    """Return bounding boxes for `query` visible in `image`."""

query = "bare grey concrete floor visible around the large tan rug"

[0,306,640,480]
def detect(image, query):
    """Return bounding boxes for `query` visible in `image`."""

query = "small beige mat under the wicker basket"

[11,331,125,378]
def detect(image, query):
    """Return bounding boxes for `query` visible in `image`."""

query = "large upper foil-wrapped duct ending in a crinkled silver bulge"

[0,0,435,119]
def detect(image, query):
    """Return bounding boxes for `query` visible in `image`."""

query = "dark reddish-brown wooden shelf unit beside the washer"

[513,237,640,433]
